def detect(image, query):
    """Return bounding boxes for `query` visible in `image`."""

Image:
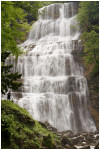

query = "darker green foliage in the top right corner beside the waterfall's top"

[77,1,99,31]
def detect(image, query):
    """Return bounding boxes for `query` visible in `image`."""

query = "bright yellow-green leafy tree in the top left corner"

[1,1,29,57]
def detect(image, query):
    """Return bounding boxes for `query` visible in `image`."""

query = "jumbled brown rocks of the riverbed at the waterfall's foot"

[39,122,99,149]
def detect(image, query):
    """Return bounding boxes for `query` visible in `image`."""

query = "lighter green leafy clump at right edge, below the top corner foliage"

[82,30,99,65]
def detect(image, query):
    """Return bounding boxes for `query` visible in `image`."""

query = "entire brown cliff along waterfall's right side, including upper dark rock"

[72,41,99,130]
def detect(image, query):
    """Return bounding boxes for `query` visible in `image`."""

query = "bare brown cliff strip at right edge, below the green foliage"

[84,66,99,130]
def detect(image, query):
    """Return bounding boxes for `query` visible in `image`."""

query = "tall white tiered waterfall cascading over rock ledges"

[5,2,96,132]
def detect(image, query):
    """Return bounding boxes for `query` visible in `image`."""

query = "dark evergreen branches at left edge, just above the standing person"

[1,51,22,94]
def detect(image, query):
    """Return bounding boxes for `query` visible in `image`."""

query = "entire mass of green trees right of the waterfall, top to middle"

[77,1,99,76]
